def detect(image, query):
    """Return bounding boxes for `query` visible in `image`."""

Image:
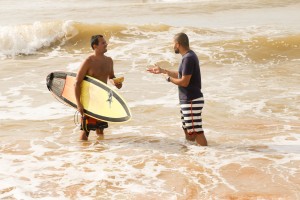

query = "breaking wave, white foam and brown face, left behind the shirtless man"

[0,21,168,56]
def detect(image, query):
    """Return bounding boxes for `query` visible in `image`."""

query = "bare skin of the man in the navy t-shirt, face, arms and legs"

[147,40,207,146]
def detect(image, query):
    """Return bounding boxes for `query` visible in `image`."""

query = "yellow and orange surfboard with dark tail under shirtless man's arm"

[46,71,131,122]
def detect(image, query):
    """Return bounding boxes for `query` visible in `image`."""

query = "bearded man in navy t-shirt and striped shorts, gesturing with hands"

[148,33,207,146]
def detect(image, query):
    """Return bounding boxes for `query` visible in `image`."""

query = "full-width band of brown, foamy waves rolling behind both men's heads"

[0,21,300,65]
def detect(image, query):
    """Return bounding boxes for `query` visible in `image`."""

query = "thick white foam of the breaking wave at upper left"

[0,21,78,56]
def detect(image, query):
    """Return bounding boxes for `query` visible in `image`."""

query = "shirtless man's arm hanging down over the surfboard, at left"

[74,59,88,115]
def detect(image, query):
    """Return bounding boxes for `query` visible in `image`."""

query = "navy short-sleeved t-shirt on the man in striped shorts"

[178,50,203,101]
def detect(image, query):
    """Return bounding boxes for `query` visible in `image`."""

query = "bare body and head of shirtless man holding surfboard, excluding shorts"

[75,35,122,140]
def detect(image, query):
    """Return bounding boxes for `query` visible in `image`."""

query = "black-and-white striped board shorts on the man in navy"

[180,97,204,133]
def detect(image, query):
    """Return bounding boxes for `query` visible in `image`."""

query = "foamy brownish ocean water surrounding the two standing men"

[0,0,300,200]
